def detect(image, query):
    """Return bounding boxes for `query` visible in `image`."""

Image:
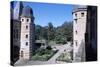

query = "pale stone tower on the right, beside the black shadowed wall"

[73,5,87,62]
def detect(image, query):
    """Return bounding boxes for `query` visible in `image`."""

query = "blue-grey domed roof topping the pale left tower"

[21,6,33,18]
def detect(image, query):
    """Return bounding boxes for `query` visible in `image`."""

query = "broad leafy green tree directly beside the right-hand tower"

[55,21,73,44]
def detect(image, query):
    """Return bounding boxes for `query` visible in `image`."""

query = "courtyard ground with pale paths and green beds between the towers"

[15,42,72,66]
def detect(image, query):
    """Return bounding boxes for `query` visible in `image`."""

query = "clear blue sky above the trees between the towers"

[12,2,73,27]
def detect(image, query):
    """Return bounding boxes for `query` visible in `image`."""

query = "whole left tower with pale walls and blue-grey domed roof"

[20,6,35,60]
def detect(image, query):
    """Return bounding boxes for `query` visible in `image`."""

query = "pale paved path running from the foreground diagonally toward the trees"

[15,43,72,66]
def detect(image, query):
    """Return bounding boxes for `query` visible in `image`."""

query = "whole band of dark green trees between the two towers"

[35,21,73,44]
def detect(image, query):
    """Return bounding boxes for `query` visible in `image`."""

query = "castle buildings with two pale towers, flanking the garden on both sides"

[10,2,97,63]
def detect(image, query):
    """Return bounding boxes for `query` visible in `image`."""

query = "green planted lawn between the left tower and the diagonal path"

[32,49,57,61]
